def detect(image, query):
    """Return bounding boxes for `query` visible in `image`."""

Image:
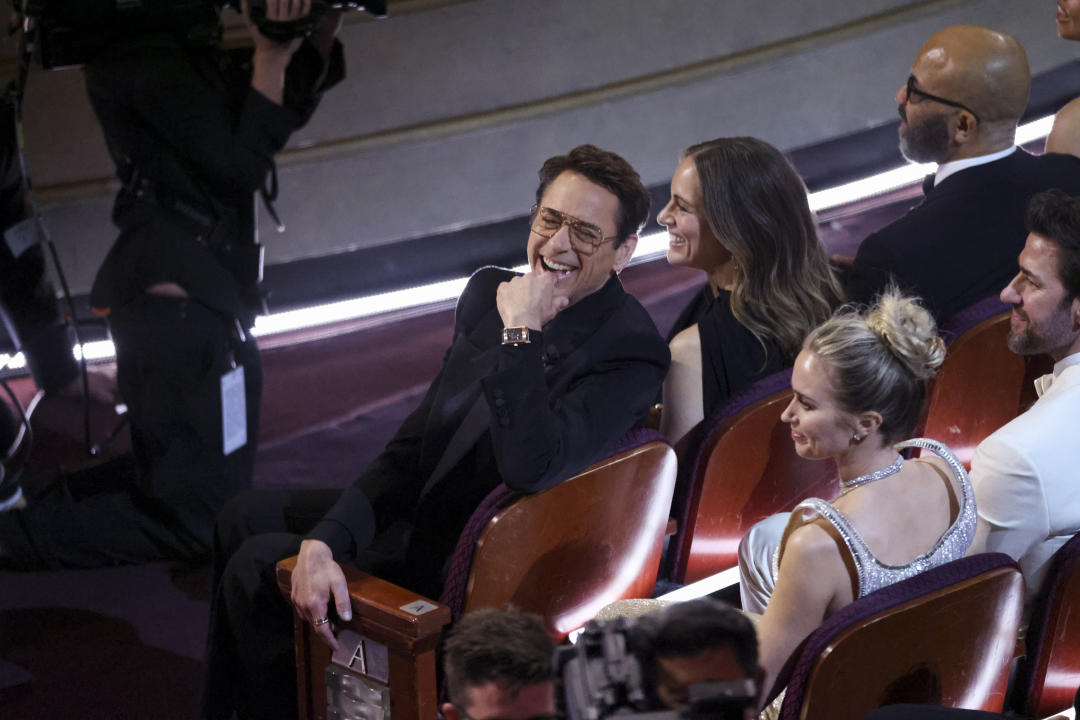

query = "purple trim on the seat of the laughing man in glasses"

[440,427,664,622]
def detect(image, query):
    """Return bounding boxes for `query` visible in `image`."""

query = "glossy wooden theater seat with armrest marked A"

[278,430,675,720]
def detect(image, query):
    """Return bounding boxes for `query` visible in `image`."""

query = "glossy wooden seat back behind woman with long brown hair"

[665,370,839,584]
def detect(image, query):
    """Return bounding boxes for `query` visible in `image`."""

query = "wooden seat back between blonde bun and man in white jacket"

[921,298,1050,467]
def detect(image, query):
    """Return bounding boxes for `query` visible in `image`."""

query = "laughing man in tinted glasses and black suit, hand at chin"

[203,146,669,719]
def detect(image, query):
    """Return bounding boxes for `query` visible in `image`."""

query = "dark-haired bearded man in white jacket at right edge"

[971,190,1080,597]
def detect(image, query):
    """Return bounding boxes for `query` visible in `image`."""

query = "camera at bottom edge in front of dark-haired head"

[554,617,757,720]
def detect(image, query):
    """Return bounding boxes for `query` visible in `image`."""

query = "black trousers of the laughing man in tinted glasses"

[201,490,340,720]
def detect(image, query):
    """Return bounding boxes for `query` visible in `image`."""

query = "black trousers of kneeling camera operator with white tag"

[0,295,262,569]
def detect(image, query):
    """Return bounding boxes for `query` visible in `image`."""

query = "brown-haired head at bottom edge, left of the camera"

[442,608,555,720]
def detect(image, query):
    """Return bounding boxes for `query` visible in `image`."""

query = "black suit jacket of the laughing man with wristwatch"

[309,268,670,593]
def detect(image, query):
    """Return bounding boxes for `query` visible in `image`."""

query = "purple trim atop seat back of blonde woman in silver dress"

[774,553,1020,720]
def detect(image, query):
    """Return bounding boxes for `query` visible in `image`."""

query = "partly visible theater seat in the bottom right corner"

[1012,535,1080,718]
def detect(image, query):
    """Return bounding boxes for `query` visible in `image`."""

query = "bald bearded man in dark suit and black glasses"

[846,25,1080,320]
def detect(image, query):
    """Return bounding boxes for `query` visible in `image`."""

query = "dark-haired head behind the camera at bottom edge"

[635,598,761,719]
